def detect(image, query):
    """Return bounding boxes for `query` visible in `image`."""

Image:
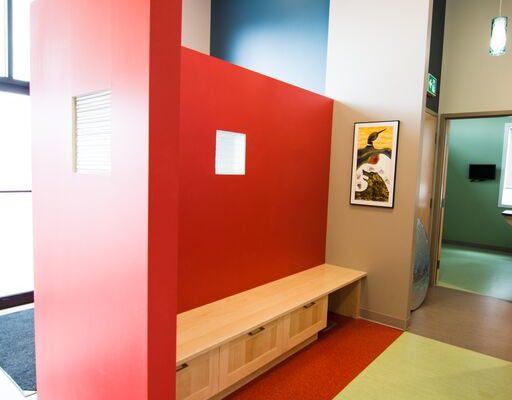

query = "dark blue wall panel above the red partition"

[211,0,329,94]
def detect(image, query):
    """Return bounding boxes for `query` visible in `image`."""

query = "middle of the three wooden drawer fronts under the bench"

[219,320,283,390]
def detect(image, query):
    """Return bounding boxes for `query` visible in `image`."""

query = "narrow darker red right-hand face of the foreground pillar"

[147,0,182,400]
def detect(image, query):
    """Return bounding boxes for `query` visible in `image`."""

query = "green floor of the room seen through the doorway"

[438,244,512,300]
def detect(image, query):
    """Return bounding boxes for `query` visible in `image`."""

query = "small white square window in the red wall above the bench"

[215,130,246,175]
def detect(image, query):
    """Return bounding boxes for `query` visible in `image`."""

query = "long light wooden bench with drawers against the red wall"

[176,264,366,400]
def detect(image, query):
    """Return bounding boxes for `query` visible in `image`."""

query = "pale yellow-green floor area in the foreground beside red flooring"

[336,333,512,400]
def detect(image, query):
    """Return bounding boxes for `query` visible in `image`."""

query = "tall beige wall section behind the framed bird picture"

[326,0,431,327]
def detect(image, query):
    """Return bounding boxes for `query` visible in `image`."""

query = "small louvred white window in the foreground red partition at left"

[73,90,112,175]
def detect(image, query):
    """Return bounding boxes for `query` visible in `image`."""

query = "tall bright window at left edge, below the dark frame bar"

[0,91,34,300]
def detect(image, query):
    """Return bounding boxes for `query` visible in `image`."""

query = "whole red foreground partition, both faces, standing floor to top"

[31,0,181,400]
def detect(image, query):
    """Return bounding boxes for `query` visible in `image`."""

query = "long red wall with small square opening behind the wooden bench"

[178,48,333,312]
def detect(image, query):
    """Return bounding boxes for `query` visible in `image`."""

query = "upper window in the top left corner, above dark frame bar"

[0,0,31,94]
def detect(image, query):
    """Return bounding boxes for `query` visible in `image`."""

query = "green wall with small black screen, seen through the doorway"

[443,118,512,250]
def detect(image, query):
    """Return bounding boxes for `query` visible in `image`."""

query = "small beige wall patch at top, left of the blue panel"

[181,0,211,54]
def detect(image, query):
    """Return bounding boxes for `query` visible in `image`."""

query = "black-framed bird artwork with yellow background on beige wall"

[350,121,400,208]
